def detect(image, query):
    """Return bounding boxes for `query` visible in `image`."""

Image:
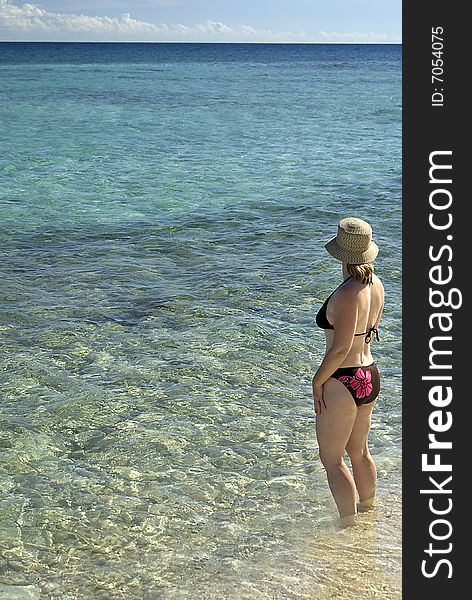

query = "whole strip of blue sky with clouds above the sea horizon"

[0,0,401,43]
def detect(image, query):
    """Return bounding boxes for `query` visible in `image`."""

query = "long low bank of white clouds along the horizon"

[0,0,399,43]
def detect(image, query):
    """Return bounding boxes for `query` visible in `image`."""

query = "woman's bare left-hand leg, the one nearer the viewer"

[316,378,357,517]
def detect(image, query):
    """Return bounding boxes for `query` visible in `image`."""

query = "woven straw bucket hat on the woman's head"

[325,217,379,265]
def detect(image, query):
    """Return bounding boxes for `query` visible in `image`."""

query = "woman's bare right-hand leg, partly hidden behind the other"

[346,401,377,510]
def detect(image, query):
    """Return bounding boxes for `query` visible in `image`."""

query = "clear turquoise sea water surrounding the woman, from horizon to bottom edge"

[0,43,401,600]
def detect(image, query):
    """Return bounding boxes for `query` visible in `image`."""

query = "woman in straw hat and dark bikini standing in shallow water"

[313,217,384,526]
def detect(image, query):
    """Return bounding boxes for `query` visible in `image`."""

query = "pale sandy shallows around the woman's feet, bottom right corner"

[181,481,402,600]
